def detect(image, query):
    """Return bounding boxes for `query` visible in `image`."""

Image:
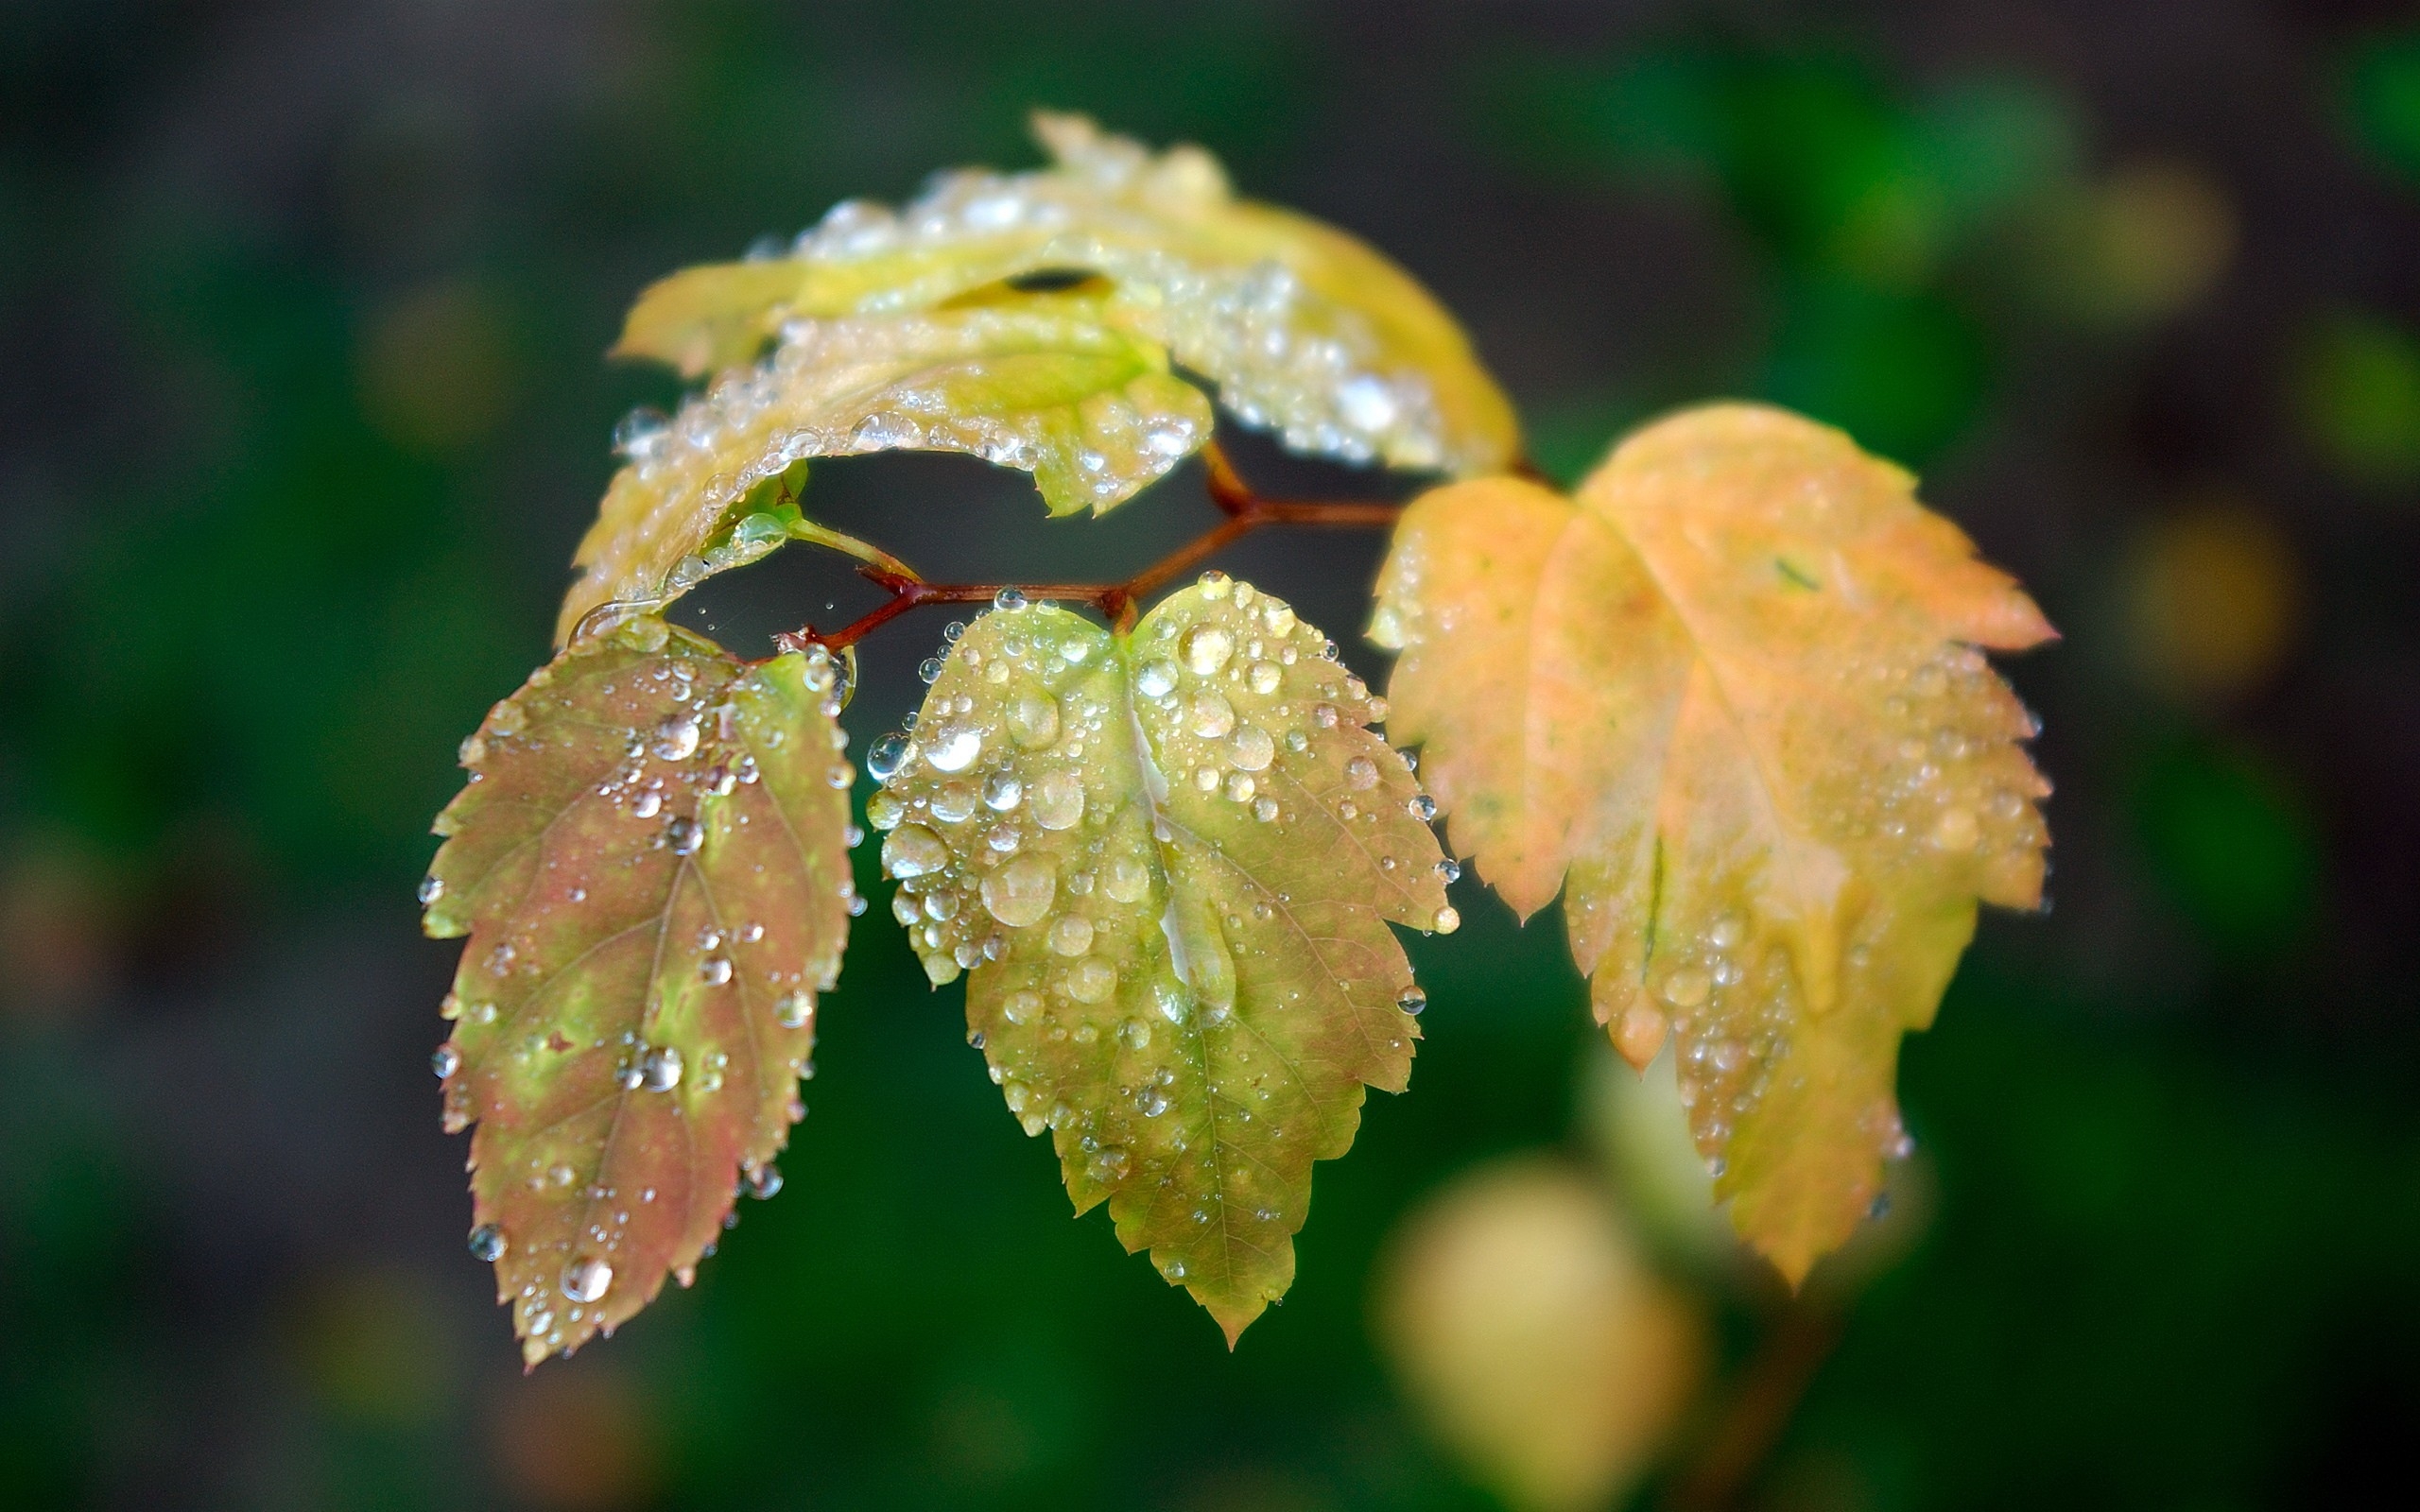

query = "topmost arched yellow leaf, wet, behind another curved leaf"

[617,113,1520,474]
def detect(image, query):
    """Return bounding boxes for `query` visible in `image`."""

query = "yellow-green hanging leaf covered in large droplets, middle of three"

[869,576,1460,1343]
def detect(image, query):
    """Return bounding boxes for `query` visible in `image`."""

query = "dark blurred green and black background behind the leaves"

[0,0,2420,1509]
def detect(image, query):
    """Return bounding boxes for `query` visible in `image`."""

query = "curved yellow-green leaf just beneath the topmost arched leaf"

[554,296,1213,641]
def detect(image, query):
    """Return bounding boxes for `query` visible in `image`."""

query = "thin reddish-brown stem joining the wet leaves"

[774,440,1404,651]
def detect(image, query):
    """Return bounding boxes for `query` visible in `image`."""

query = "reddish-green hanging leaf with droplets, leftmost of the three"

[426,619,852,1365]
